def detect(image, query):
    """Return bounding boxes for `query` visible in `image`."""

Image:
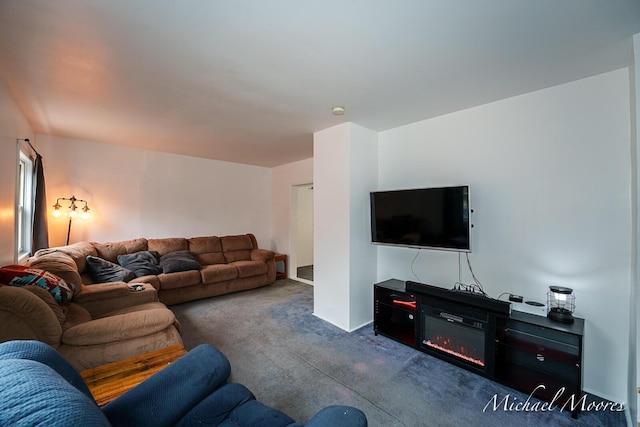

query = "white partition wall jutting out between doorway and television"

[313,123,378,331]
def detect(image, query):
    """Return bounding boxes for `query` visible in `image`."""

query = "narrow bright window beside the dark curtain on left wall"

[16,151,35,261]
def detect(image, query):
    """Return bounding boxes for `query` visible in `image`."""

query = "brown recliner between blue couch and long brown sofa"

[0,285,182,370]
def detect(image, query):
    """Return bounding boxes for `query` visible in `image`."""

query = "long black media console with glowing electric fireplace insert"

[373,279,584,418]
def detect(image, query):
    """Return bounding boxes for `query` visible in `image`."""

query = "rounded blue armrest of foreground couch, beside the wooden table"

[102,344,231,427]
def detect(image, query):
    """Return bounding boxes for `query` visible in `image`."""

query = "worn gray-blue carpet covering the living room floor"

[171,279,625,427]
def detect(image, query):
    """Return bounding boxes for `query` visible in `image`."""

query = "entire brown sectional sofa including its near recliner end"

[0,234,276,370]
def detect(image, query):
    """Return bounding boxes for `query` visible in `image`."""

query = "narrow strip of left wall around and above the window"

[0,80,35,266]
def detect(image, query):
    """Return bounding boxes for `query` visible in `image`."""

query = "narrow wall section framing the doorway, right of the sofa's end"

[271,159,313,276]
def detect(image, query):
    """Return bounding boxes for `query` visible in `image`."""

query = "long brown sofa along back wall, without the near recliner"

[28,234,276,309]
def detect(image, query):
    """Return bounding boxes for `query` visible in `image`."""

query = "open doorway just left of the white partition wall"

[289,183,313,284]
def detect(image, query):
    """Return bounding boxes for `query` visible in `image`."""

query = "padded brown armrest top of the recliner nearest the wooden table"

[62,308,176,346]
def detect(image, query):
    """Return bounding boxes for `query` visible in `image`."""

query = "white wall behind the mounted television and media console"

[378,69,632,401]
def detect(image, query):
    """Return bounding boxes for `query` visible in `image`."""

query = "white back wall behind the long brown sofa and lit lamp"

[38,135,271,248]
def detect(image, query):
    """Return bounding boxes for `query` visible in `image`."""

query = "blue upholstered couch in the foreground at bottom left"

[0,341,367,427]
